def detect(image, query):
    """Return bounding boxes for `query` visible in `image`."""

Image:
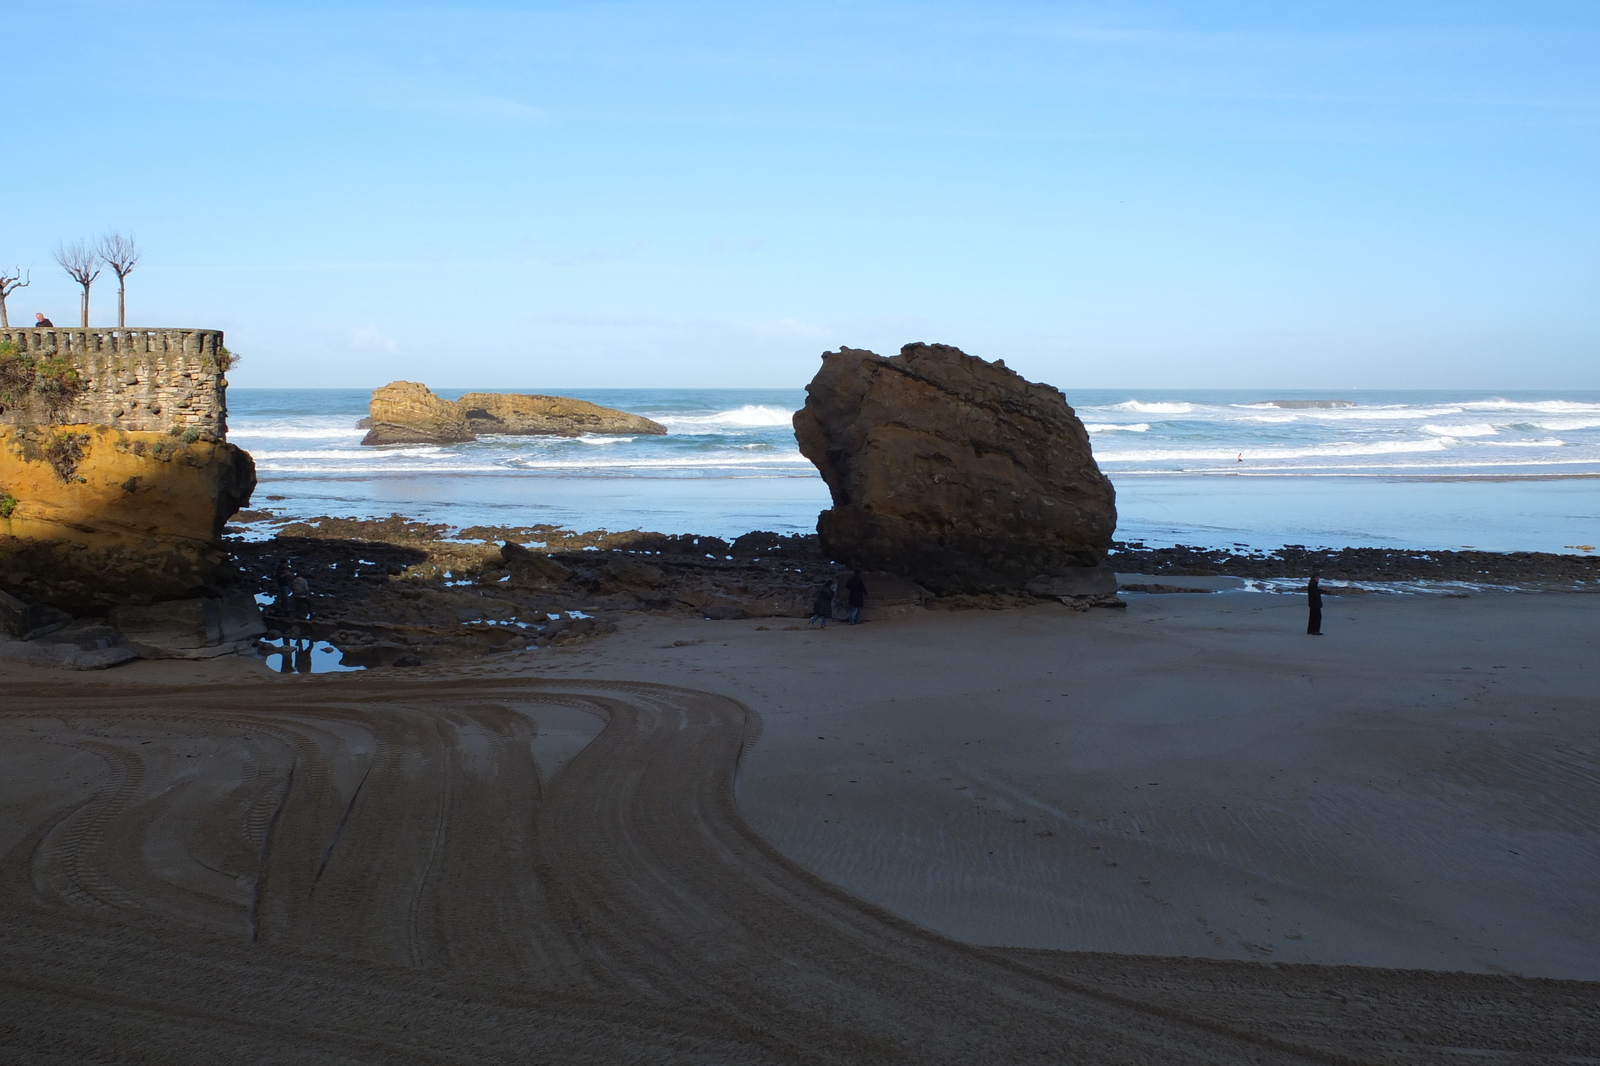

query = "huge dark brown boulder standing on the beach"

[794,344,1117,597]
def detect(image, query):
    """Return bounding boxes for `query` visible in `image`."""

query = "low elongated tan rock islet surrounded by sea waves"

[362,381,667,445]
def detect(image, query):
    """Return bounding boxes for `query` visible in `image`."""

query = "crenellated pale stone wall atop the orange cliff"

[0,327,227,440]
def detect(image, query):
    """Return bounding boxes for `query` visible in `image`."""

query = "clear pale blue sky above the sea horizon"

[0,0,1600,389]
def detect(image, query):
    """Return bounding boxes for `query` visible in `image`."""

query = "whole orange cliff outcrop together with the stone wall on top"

[0,328,256,611]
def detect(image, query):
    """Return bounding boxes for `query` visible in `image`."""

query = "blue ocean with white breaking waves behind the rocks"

[229,387,1600,552]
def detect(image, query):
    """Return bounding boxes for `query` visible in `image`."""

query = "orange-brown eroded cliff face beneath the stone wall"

[0,426,256,610]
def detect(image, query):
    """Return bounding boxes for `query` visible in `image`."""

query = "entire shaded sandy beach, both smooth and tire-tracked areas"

[0,594,1600,1063]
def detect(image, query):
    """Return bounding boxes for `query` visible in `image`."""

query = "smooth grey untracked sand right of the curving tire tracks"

[557,592,1600,980]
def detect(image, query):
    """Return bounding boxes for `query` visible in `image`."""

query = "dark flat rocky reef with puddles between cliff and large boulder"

[232,515,851,666]
